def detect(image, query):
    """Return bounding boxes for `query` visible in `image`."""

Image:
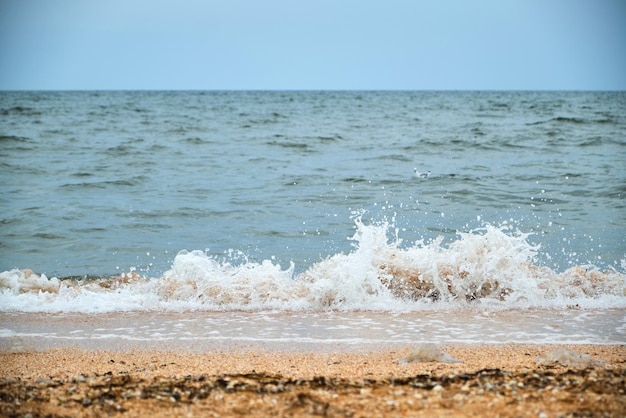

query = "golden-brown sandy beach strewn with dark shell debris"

[0,344,626,417]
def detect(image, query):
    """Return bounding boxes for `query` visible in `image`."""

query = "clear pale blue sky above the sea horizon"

[0,0,626,90]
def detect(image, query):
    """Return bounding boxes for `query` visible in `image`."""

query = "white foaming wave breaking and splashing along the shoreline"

[0,217,626,313]
